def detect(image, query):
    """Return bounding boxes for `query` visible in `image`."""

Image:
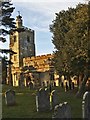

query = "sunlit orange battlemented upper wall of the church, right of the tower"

[23,54,54,72]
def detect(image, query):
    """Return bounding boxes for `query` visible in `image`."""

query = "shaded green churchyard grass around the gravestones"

[2,85,82,118]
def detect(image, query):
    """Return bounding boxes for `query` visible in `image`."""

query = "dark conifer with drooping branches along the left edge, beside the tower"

[0,0,15,83]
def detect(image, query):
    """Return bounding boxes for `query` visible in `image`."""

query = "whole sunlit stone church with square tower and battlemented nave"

[8,15,58,86]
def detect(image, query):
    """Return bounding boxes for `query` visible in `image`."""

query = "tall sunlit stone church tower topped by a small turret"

[10,15,35,86]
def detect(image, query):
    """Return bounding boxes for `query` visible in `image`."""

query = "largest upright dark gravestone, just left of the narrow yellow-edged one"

[36,88,50,111]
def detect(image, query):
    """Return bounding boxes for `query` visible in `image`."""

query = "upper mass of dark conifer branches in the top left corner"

[0,0,15,42]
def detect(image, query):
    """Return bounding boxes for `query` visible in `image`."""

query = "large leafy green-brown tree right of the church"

[50,4,90,95]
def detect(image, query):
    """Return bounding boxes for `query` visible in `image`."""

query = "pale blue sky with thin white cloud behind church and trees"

[0,0,85,55]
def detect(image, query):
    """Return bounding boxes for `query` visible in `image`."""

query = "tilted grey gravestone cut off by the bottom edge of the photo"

[52,102,71,120]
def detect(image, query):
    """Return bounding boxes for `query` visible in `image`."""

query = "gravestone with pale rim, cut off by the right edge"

[82,92,90,120]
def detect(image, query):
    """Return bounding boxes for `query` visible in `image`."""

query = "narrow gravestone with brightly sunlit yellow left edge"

[50,90,58,109]
